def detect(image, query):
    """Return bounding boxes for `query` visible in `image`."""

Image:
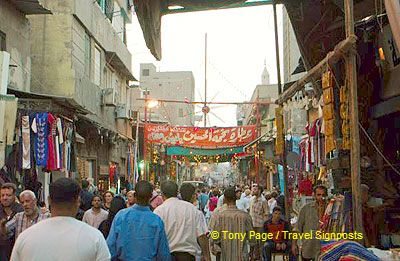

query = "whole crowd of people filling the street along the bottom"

[0,178,376,261]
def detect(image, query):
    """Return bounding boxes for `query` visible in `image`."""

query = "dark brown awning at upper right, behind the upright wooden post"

[282,0,376,71]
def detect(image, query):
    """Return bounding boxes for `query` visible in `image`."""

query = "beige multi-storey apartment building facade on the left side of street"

[30,0,135,190]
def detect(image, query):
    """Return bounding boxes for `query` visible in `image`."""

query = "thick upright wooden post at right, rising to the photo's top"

[344,0,363,232]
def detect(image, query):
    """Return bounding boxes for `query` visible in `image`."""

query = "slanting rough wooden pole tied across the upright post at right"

[276,34,357,104]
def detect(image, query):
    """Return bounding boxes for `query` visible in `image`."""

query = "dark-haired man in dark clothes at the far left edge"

[0,183,24,260]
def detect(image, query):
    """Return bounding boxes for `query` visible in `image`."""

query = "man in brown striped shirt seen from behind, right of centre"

[210,187,254,261]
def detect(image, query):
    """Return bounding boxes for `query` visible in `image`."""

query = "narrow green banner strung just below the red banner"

[167,146,243,156]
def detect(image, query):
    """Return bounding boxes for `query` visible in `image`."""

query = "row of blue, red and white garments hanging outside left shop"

[5,110,75,180]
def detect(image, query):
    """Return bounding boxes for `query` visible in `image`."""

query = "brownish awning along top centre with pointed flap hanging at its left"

[133,0,281,60]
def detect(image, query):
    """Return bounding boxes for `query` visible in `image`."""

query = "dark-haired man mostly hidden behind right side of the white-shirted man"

[179,183,211,260]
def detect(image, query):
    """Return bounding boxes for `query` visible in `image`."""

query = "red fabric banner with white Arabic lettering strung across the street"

[144,124,256,149]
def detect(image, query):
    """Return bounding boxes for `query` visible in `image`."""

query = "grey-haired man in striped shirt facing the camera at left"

[1,190,50,239]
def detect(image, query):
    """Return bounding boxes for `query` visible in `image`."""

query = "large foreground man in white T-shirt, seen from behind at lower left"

[11,178,111,261]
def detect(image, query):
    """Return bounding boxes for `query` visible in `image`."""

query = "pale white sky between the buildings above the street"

[127,5,282,127]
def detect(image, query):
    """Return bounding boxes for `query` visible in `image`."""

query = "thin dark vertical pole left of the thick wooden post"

[272,0,290,220]
